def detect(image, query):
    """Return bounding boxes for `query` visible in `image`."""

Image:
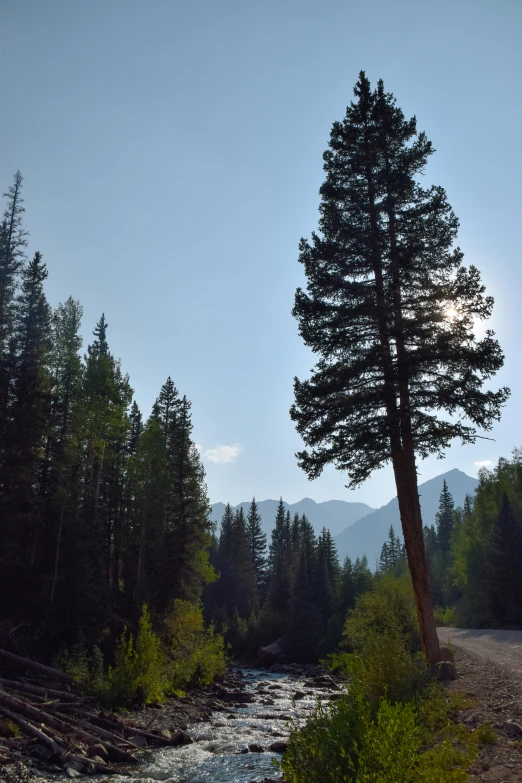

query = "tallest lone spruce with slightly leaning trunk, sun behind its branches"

[291,72,508,661]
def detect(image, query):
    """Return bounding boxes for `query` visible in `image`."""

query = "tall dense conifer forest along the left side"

[0,172,215,668]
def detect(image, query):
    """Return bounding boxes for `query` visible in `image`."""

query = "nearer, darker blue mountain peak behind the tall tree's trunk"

[335,468,478,567]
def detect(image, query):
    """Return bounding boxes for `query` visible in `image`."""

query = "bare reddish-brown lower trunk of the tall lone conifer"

[392,448,440,664]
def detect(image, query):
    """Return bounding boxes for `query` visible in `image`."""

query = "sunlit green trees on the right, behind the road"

[378,460,522,628]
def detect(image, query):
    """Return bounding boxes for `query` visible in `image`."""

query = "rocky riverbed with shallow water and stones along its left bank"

[0,664,340,783]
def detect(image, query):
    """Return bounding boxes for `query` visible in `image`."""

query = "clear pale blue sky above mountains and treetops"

[0,0,522,507]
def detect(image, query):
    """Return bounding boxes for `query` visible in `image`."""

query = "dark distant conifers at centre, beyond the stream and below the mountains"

[205,499,373,660]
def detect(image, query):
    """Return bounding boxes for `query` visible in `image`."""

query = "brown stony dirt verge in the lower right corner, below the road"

[448,647,522,783]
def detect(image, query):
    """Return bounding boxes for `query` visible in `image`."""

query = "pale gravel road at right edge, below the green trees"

[437,628,522,676]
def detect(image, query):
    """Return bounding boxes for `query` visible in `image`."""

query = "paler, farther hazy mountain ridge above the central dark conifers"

[211,498,375,536]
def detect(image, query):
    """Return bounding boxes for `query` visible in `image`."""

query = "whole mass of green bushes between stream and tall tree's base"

[282,577,484,783]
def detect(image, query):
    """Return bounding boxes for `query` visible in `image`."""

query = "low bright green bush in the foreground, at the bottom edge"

[282,694,475,783]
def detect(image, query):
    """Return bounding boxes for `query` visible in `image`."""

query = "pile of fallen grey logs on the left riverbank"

[0,649,186,777]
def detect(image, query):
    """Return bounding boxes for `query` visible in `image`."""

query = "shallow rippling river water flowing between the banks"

[110,669,338,783]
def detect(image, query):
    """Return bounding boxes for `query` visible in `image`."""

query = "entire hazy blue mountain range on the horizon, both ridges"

[211,469,478,567]
